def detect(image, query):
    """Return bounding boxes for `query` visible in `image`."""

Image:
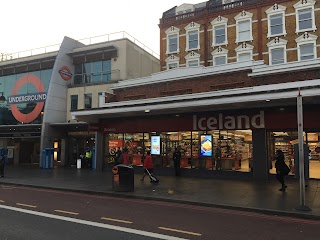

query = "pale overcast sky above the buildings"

[0,0,202,54]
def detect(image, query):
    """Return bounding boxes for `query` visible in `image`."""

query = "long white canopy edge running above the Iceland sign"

[71,79,320,118]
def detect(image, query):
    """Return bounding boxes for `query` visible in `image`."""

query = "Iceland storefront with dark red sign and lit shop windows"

[84,107,320,179]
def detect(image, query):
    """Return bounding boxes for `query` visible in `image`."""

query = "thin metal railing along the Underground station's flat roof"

[0,31,160,62]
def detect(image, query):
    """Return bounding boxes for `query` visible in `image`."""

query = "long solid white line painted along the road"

[0,204,188,240]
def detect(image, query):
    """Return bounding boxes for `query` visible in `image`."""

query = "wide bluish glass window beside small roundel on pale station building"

[74,60,111,84]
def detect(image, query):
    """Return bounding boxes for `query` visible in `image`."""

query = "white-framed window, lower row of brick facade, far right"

[296,32,318,61]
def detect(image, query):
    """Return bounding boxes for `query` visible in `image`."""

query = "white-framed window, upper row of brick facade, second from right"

[266,4,287,38]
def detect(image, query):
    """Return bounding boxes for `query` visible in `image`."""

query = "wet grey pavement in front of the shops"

[0,166,320,220]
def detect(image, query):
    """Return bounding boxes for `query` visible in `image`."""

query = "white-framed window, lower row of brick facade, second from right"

[267,37,288,65]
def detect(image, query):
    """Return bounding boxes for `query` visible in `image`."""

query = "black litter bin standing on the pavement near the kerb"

[112,164,134,192]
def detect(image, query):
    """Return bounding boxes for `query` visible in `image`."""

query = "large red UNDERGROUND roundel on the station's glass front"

[9,74,46,123]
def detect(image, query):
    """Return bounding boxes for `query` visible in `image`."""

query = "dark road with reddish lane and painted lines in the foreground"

[0,185,320,240]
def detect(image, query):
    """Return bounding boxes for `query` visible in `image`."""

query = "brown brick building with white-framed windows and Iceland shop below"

[71,0,320,180]
